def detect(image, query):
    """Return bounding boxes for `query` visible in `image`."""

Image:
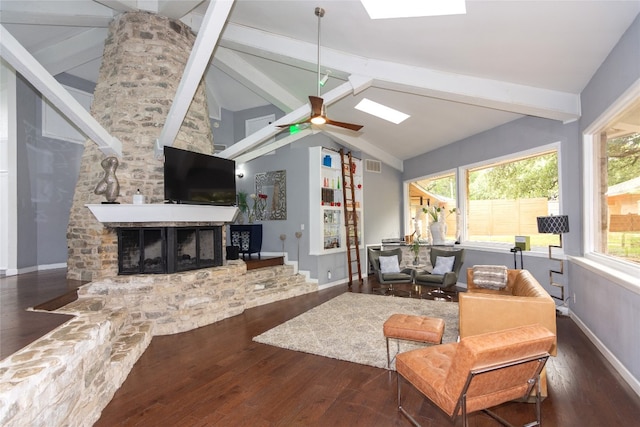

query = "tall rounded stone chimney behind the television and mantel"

[67,12,214,281]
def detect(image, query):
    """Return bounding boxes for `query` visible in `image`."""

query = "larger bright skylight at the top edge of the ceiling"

[360,0,467,19]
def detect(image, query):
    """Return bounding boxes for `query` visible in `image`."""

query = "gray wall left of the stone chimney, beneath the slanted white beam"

[16,76,83,269]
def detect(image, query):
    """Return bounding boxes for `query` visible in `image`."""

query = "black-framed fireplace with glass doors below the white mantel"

[118,226,222,274]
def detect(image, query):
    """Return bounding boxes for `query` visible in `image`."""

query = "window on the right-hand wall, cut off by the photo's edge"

[587,100,640,265]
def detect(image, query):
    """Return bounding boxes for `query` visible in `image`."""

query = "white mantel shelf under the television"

[85,204,238,224]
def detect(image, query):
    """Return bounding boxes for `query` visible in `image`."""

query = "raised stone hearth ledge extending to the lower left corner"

[0,261,318,427]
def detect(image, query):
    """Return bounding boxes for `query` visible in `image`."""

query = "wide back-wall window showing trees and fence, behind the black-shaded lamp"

[466,149,560,247]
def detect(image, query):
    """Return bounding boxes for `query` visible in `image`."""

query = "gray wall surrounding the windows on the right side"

[403,12,640,390]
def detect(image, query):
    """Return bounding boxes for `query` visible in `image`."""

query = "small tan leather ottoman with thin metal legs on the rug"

[382,314,444,368]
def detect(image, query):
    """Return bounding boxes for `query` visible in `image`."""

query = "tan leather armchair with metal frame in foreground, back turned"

[396,325,555,426]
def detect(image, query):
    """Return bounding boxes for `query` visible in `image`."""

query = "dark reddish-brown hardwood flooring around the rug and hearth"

[0,271,640,427]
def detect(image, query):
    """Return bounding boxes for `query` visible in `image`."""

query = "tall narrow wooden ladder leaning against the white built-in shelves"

[340,148,362,287]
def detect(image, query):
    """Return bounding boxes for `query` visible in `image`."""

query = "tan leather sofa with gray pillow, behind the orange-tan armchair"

[459,268,558,396]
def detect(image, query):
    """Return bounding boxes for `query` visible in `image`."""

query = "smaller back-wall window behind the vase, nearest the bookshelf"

[408,171,462,242]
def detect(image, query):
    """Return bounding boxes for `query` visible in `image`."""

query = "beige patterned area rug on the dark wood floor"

[253,292,458,369]
